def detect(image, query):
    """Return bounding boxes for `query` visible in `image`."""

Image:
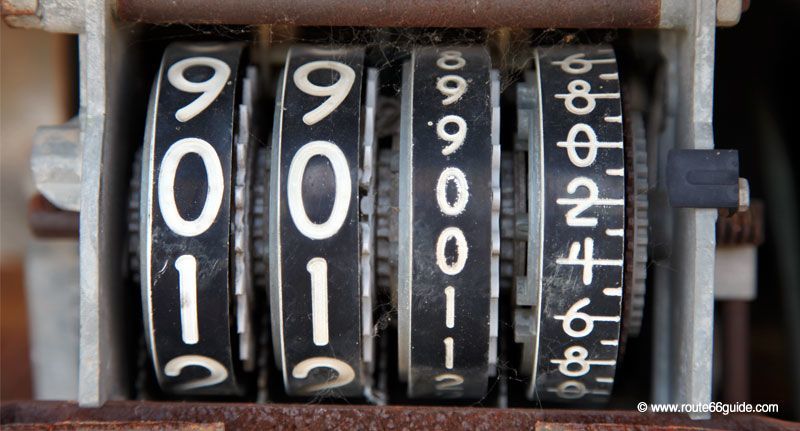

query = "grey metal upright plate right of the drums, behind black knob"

[648,0,717,419]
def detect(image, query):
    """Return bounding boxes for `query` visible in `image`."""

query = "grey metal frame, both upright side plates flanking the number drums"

[3,0,724,416]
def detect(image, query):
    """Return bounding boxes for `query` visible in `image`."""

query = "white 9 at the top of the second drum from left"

[293,60,356,126]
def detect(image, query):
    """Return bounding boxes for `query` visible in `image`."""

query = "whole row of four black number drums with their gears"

[129,37,647,405]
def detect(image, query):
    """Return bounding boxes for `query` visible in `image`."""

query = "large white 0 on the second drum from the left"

[286,141,351,243]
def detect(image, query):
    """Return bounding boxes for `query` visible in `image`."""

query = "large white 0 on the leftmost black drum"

[158,138,225,237]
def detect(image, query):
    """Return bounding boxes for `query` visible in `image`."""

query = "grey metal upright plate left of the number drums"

[78,0,141,406]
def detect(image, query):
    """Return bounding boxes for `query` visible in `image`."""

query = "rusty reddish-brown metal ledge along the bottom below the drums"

[0,401,797,430]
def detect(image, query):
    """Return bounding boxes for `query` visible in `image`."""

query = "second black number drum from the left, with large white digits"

[270,48,377,396]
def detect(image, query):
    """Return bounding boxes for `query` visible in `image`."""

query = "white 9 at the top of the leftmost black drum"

[167,57,231,123]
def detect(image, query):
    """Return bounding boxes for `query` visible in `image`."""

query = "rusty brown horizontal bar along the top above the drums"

[116,0,662,28]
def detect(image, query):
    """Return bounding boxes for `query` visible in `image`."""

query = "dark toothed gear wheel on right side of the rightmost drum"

[625,112,649,337]
